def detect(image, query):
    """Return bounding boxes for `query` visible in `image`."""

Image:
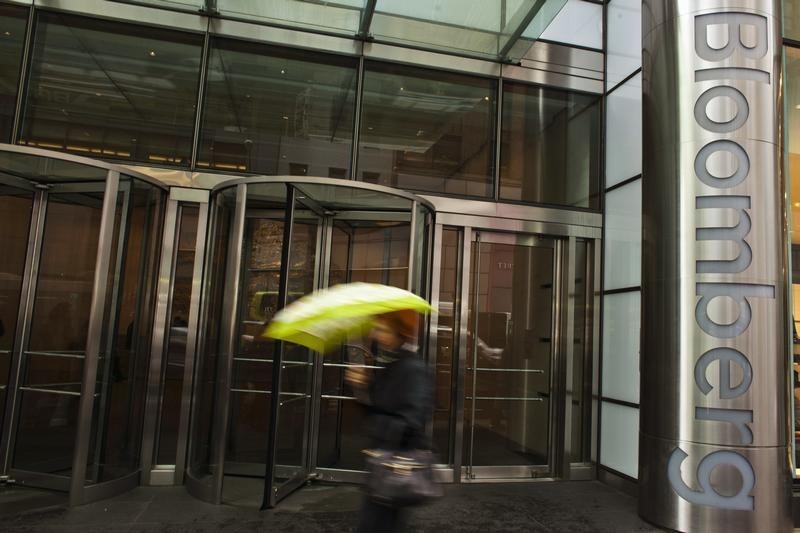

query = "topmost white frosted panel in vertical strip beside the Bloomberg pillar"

[606,0,642,90]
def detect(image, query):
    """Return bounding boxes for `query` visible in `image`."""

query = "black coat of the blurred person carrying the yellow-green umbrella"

[368,349,433,450]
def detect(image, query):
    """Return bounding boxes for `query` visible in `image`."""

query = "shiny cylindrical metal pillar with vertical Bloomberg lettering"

[639,0,791,532]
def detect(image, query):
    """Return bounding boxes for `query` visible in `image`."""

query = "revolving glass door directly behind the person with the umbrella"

[186,178,433,507]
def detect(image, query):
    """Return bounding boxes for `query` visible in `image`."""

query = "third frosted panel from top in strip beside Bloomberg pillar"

[603,183,642,291]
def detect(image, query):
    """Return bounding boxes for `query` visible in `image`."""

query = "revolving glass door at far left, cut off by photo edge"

[0,145,166,504]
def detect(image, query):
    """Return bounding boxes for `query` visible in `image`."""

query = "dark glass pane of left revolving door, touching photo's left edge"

[0,182,33,422]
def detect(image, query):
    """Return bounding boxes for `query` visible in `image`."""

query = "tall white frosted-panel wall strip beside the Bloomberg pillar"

[599,0,642,478]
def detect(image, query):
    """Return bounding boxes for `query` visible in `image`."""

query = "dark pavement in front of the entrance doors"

[0,481,661,533]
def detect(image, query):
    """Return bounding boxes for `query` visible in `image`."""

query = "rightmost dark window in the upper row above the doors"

[500,83,600,209]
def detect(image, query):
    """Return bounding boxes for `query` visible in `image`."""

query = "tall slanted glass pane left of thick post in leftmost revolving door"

[12,189,103,475]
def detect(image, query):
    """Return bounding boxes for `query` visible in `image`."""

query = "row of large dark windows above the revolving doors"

[0,6,601,210]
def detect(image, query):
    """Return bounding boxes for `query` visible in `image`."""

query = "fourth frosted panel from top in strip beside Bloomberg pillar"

[602,291,641,404]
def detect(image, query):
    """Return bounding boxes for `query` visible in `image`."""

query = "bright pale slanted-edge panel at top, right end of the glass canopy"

[542,0,603,50]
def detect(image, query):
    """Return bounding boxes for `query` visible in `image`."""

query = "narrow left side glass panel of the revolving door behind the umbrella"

[187,187,236,481]
